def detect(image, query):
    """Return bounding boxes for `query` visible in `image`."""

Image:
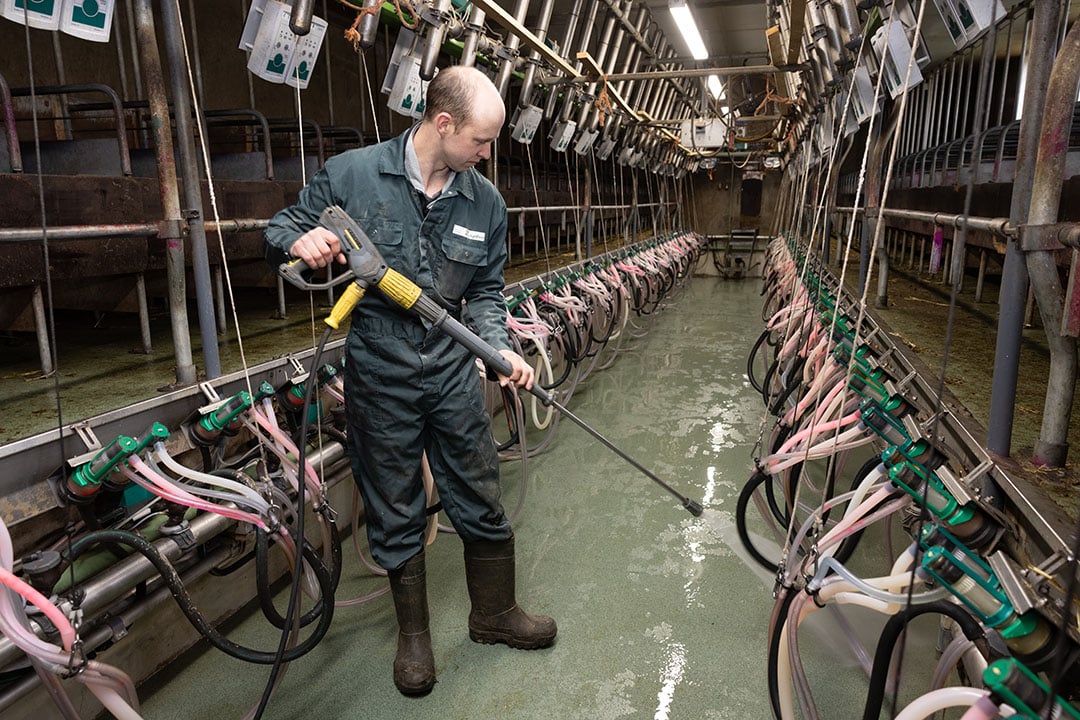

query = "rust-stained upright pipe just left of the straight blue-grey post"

[135,0,198,385]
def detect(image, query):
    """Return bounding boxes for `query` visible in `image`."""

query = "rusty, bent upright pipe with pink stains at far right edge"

[1027,18,1080,467]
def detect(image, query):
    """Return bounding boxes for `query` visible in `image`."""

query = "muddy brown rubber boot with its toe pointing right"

[464,536,557,650]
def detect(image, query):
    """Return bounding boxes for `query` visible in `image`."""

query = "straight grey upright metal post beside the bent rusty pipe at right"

[986,0,1061,456]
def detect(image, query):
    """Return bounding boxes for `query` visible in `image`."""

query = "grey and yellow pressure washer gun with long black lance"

[279,205,702,516]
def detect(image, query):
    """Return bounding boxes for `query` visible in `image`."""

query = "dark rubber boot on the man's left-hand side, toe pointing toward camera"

[387,551,435,695]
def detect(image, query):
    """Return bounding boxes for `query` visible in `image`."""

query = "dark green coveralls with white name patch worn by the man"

[265,127,511,570]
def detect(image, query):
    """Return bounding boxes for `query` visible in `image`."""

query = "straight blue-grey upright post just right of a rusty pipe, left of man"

[160,0,221,380]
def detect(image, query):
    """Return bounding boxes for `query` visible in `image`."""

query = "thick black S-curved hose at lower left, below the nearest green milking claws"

[67,530,334,665]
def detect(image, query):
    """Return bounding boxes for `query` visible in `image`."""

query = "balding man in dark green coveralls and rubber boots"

[266,67,556,695]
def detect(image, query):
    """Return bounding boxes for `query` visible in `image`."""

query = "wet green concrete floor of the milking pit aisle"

[132,277,894,720]
